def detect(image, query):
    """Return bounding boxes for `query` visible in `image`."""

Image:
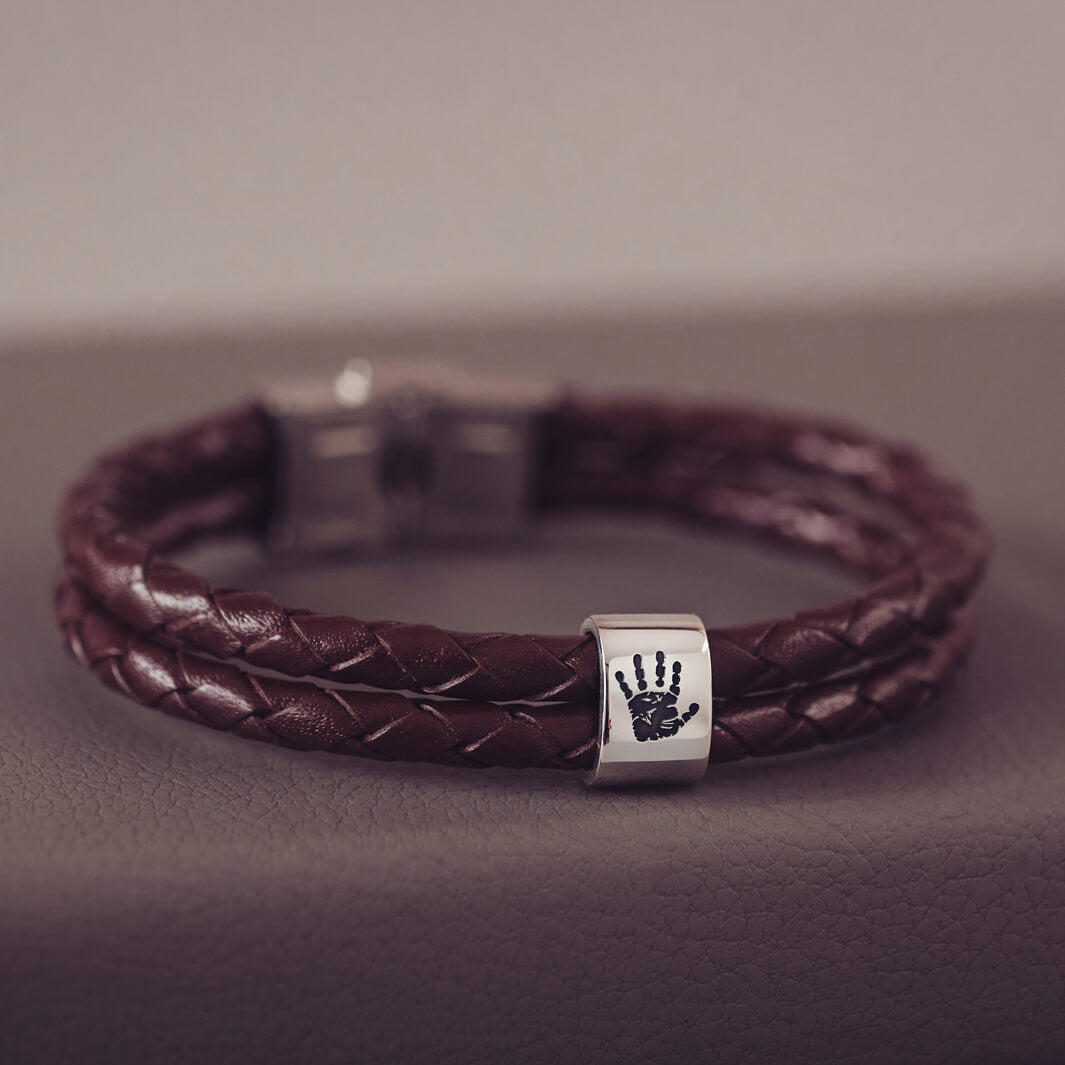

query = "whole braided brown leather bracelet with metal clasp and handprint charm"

[56,363,989,784]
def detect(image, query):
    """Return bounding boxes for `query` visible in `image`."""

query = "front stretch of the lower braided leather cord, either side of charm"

[56,578,971,768]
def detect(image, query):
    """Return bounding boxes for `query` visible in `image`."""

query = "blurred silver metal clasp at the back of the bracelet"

[262,359,558,552]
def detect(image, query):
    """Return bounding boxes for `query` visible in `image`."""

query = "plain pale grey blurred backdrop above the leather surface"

[6,0,1065,335]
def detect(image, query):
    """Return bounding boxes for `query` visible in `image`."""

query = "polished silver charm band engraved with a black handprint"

[580,613,714,787]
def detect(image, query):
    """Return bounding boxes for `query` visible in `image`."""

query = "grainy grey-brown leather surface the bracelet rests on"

[0,305,1065,1065]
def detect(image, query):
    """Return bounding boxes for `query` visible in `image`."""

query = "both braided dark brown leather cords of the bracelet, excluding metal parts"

[58,364,989,783]
